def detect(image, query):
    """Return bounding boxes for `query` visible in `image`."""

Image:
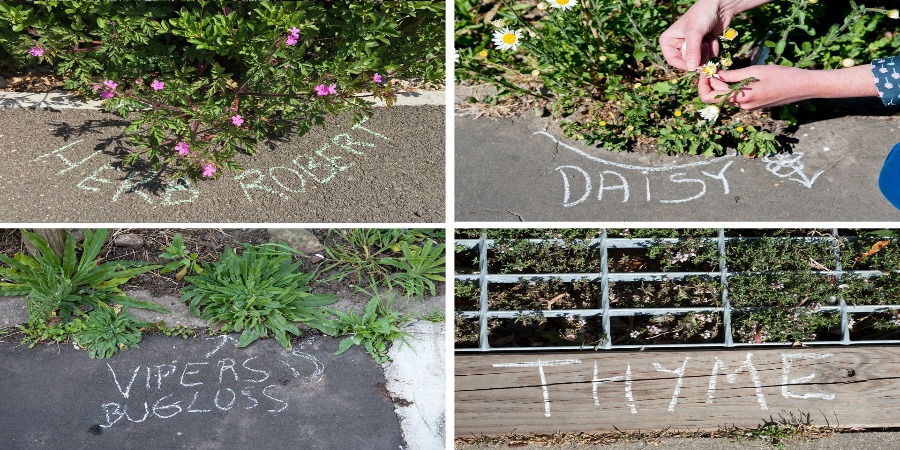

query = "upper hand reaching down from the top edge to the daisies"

[659,0,770,71]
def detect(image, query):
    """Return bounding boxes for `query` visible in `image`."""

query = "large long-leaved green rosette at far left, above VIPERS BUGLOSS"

[0,229,169,322]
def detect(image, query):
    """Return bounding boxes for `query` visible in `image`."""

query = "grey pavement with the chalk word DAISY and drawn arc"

[455,111,900,222]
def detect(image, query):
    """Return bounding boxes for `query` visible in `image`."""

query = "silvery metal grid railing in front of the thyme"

[454,229,900,352]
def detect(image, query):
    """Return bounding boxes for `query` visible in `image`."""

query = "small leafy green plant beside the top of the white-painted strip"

[323,295,409,364]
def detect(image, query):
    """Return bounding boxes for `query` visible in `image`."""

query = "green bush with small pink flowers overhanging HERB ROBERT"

[0,0,444,180]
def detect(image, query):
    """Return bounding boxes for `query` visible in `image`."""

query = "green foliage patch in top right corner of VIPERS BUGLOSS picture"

[323,228,445,297]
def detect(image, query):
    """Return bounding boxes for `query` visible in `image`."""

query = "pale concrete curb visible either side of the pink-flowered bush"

[0,91,447,109]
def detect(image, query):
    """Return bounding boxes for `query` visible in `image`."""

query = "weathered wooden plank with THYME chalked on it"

[455,347,900,436]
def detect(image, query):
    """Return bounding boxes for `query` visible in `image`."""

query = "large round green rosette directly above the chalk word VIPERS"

[181,244,337,348]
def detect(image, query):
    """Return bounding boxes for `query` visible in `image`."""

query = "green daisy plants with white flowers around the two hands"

[455,0,900,156]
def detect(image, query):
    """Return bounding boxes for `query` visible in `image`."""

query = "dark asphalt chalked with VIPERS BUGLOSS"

[0,335,404,449]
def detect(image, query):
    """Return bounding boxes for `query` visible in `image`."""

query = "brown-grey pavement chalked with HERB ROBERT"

[0,106,446,223]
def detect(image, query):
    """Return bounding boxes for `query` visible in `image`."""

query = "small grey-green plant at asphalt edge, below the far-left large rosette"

[74,304,150,359]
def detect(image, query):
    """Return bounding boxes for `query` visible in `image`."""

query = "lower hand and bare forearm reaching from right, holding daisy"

[697,64,878,109]
